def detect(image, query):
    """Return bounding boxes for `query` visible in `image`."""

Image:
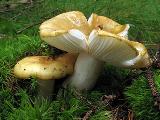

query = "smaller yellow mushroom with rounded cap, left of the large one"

[13,53,77,98]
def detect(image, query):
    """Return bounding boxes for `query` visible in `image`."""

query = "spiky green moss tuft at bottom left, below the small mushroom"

[7,91,60,120]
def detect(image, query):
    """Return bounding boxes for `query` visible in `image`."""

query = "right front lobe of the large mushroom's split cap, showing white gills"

[90,30,151,68]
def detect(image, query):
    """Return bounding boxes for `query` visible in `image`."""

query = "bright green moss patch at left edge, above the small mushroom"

[0,35,41,77]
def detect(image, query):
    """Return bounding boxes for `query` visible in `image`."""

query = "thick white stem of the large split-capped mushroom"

[68,52,103,90]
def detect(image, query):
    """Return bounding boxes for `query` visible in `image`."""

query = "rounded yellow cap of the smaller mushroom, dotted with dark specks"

[14,54,76,80]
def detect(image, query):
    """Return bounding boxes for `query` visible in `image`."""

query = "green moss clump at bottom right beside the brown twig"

[125,70,160,120]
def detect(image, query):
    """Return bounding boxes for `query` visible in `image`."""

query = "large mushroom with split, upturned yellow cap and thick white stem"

[40,11,151,90]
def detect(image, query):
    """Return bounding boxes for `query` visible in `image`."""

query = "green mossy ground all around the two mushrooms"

[0,0,160,120]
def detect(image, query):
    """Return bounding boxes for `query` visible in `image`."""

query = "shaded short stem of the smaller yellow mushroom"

[38,80,55,99]
